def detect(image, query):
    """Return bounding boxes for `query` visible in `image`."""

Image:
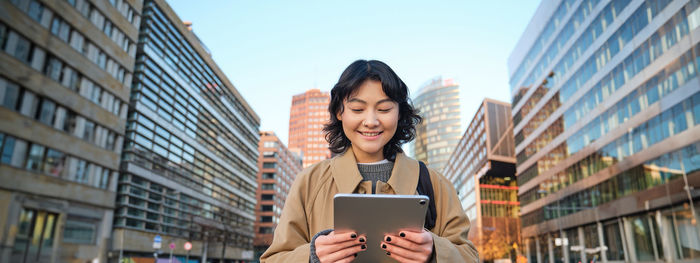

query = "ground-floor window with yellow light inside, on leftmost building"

[10,209,58,262]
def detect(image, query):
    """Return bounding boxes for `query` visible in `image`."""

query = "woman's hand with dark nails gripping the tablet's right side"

[381,229,433,263]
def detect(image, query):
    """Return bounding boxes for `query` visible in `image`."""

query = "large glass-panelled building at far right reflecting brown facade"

[508,0,700,262]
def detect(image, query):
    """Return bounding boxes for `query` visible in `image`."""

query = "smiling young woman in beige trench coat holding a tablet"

[260,60,478,262]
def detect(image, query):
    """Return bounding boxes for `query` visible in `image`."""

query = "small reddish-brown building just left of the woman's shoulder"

[253,131,302,258]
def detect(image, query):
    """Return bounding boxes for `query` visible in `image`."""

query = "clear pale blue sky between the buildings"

[168,0,539,144]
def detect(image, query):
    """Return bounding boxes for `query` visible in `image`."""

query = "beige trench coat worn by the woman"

[260,149,479,262]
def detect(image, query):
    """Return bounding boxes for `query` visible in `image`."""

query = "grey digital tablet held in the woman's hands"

[333,194,430,262]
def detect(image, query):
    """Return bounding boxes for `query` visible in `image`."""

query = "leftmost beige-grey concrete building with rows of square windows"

[0,0,141,263]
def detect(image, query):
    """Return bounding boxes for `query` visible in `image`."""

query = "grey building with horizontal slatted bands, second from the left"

[116,0,260,262]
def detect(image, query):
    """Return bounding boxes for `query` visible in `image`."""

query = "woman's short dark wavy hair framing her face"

[323,60,423,160]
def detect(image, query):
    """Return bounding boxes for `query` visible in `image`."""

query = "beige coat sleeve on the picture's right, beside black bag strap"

[432,171,479,263]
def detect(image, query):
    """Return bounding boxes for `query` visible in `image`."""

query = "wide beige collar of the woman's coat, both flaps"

[331,147,420,195]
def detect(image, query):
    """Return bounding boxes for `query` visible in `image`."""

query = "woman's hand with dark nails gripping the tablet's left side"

[314,231,367,263]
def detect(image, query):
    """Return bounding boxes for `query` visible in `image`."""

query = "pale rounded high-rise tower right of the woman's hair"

[409,77,462,171]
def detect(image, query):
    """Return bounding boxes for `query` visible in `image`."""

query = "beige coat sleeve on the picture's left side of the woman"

[260,173,311,262]
